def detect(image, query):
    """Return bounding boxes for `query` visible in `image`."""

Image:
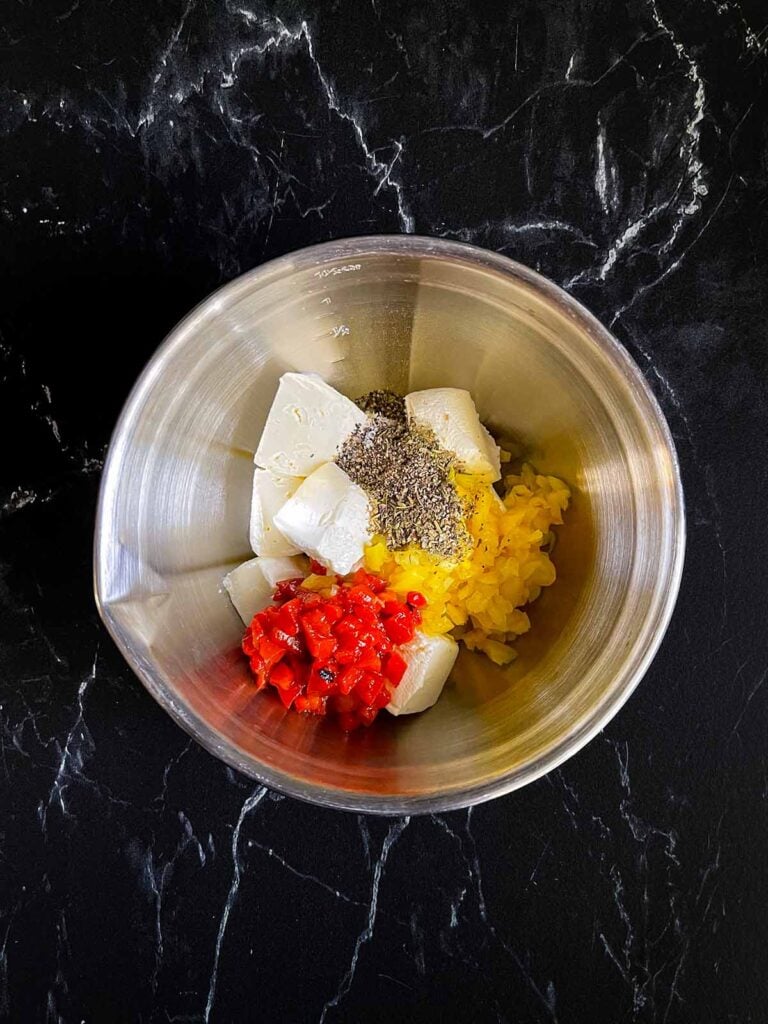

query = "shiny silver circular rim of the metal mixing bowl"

[93,234,686,815]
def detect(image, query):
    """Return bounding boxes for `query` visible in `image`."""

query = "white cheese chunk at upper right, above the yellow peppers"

[406,387,502,482]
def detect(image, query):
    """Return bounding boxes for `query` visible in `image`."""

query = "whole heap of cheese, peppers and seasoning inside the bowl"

[224,373,570,730]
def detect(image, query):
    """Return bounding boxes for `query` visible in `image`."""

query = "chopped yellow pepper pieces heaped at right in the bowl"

[366,466,570,665]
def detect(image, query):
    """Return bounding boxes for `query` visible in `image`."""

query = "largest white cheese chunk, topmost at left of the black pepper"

[254,374,367,476]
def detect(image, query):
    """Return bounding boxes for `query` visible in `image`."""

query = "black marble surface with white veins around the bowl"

[0,0,768,1024]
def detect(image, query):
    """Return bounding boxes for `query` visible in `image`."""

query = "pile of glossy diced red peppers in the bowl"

[243,577,426,730]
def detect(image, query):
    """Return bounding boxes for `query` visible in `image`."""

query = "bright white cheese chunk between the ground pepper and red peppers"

[274,462,371,575]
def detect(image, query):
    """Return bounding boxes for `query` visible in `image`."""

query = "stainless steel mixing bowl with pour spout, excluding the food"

[95,237,685,813]
